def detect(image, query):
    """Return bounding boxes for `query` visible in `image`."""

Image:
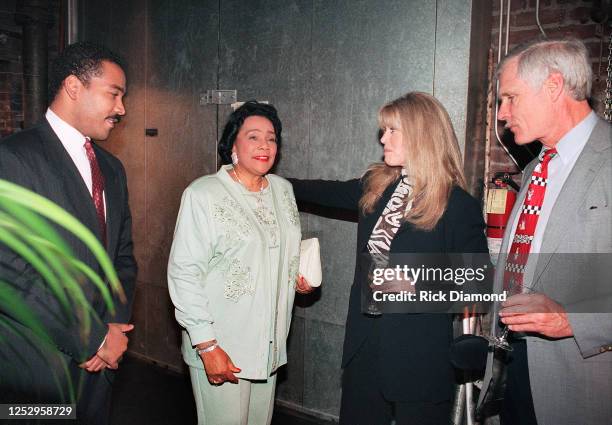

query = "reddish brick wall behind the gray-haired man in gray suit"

[489,0,611,176]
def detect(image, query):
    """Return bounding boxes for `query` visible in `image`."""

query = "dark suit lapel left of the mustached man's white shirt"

[40,120,99,235]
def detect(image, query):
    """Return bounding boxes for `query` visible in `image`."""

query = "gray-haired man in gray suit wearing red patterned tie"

[481,40,612,425]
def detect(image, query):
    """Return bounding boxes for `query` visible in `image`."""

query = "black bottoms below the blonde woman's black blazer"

[340,326,451,425]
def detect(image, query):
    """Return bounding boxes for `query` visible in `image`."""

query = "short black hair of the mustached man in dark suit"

[49,42,123,101]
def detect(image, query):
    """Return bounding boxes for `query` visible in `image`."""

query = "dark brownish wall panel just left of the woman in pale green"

[141,0,218,287]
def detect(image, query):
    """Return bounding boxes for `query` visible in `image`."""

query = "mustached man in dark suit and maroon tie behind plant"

[0,43,137,424]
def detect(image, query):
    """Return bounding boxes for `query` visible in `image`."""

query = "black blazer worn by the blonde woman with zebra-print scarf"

[289,179,488,402]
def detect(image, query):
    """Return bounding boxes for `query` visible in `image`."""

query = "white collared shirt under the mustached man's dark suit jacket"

[45,108,106,211]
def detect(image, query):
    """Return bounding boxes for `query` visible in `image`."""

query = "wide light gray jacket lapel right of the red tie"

[534,120,610,286]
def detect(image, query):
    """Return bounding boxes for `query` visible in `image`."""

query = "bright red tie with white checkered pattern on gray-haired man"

[504,148,557,293]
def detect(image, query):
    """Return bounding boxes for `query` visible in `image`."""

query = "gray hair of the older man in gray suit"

[497,38,593,100]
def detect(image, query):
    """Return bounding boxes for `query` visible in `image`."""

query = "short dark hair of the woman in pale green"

[217,100,283,164]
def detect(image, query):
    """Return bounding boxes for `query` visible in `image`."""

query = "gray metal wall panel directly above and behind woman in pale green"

[219,0,312,177]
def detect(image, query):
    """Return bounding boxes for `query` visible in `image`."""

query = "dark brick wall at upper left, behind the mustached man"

[0,0,60,137]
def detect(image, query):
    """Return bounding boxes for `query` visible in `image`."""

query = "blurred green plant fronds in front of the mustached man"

[0,180,125,401]
